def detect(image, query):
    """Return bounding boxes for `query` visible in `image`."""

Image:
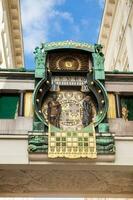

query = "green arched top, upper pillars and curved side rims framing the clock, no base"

[33,41,108,130]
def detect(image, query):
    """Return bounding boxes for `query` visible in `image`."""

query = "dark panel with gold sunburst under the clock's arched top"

[48,50,92,71]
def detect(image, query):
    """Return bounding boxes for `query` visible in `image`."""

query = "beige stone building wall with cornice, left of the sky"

[0,0,24,68]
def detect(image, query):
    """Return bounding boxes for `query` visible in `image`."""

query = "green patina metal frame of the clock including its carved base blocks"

[29,41,115,154]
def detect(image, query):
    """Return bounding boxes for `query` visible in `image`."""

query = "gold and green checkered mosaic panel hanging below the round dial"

[48,124,97,158]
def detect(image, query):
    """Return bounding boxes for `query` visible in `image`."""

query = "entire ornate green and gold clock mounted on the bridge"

[29,41,115,158]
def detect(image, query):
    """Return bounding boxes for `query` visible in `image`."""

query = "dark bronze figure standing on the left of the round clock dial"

[47,94,61,128]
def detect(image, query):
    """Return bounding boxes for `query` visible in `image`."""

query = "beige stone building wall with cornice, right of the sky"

[98,0,133,71]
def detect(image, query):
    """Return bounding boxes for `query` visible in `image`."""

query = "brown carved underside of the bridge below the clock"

[0,167,133,198]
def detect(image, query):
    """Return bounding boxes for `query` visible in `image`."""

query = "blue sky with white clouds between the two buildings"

[20,0,105,69]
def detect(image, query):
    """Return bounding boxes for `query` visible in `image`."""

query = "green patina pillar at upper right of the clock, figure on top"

[92,44,105,80]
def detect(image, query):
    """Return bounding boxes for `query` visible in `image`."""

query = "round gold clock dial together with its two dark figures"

[42,91,96,131]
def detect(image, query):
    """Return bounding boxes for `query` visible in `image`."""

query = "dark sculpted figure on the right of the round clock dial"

[82,96,93,127]
